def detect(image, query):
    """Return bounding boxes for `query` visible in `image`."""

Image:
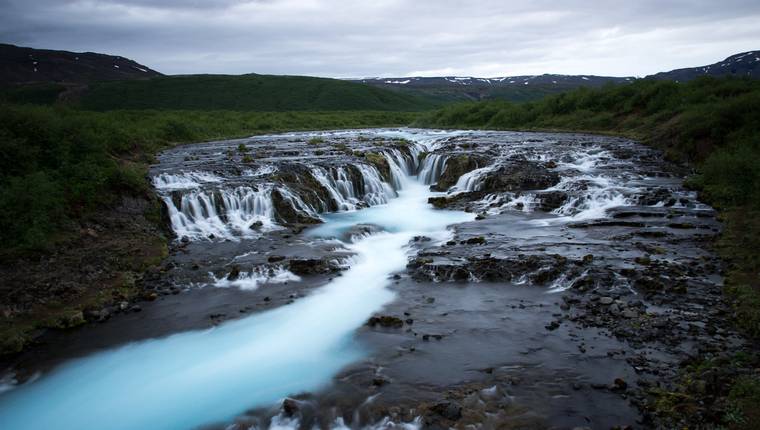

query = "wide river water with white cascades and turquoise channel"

[0,129,715,430]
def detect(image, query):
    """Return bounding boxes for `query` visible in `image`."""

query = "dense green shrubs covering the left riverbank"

[0,105,414,252]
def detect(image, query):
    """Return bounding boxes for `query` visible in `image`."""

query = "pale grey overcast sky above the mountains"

[0,0,760,78]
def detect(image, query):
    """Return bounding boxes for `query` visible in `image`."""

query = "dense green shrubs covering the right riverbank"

[416,78,760,428]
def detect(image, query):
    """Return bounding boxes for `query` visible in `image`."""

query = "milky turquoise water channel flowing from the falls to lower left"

[0,178,474,430]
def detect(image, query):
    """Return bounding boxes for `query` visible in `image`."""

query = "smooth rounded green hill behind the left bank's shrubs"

[79,75,434,111]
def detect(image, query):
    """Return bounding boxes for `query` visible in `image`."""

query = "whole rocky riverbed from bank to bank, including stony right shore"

[0,129,749,429]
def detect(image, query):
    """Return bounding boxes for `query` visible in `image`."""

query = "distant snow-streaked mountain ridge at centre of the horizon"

[353,74,635,102]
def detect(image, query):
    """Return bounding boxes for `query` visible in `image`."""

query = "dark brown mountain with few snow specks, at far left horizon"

[0,44,161,84]
